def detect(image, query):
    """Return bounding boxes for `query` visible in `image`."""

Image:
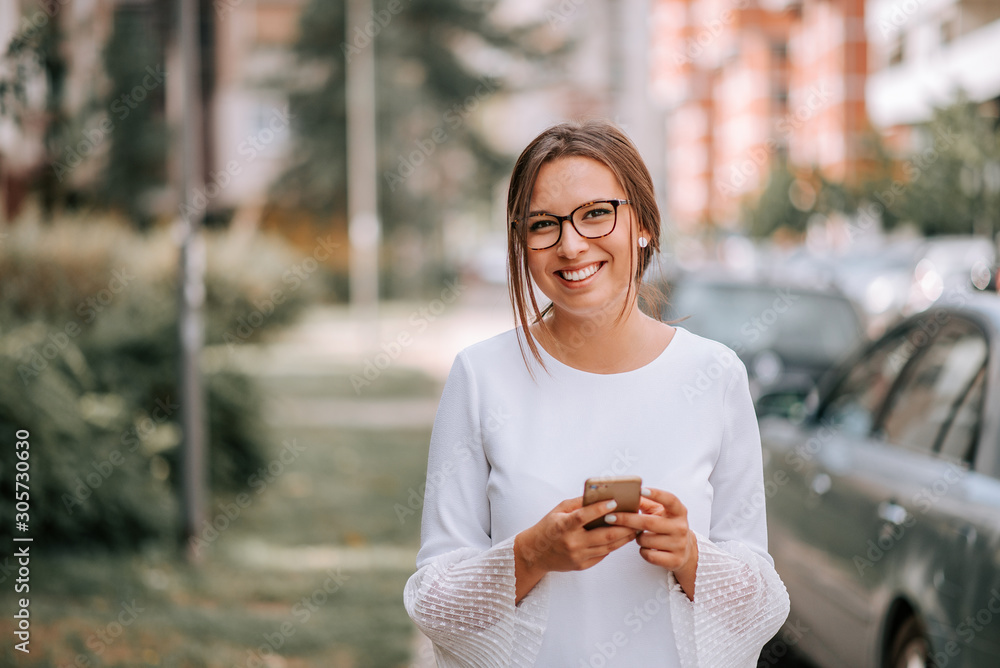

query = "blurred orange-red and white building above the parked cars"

[651,0,867,233]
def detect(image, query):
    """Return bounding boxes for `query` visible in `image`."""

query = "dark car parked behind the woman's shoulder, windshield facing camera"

[662,275,865,398]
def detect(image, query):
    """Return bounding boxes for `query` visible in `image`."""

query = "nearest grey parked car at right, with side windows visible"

[756,293,1000,668]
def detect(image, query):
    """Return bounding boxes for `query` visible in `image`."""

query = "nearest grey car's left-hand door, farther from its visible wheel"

[761,329,918,666]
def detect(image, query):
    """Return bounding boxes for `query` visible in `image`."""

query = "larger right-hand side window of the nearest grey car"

[881,321,988,452]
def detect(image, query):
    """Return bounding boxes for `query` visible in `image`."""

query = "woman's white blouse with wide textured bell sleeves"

[404,328,788,668]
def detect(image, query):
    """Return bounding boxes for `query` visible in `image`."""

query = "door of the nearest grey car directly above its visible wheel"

[820,312,988,666]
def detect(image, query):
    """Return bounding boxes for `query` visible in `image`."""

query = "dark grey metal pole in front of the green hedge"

[178,0,206,561]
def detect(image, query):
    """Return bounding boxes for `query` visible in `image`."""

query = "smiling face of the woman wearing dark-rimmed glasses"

[525,156,639,324]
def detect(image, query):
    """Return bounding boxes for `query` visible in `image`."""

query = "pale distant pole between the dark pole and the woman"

[345,0,381,334]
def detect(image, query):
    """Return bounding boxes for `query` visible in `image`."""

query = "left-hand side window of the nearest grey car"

[820,328,920,436]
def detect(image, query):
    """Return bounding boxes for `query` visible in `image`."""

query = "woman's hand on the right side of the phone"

[608,487,698,601]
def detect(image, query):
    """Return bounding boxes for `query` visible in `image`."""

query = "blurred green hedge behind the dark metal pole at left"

[0,221,321,547]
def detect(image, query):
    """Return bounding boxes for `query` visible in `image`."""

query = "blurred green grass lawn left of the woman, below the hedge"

[0,354,440,668]
